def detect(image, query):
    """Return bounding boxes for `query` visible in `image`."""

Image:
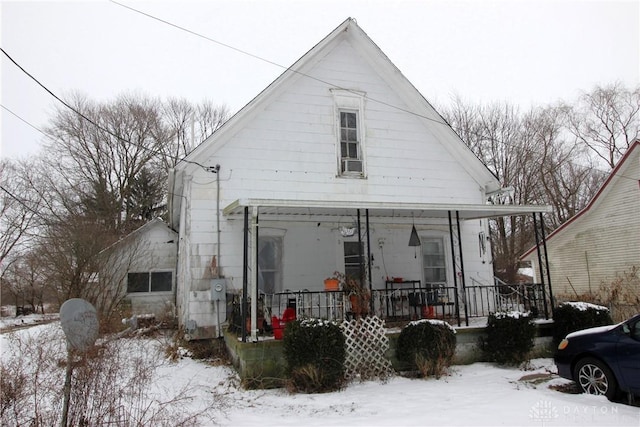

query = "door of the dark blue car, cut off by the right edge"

[616,317,640,394]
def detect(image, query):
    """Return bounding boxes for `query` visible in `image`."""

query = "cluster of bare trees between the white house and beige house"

[442,98,602,282]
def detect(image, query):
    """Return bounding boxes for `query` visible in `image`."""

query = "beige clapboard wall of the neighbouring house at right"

[522,140,640,300]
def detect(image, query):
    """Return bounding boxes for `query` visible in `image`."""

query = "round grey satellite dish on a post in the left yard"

[60,298,98,351]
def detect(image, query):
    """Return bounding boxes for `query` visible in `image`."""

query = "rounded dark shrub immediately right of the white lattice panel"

[397,320,456,378]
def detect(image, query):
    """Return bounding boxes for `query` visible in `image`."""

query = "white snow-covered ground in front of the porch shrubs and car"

[0,314,640,426]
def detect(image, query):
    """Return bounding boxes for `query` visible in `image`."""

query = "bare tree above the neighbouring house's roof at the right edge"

[568,83,640,169]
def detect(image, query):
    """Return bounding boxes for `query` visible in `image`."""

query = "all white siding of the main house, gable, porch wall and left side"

[178,27,492,334]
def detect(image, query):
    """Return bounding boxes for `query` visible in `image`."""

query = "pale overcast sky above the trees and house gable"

[0,0,640,158]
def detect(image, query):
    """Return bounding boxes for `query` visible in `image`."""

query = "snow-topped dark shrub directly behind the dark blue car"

[553,302,613,344]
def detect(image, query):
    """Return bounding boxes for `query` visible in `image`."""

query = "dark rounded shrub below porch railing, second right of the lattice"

[481,311,536,365]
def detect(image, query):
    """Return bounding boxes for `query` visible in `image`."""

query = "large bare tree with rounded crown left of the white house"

[46,95,168,231]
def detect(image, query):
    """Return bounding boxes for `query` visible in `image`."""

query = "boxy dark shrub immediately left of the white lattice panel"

[283,319,345,393]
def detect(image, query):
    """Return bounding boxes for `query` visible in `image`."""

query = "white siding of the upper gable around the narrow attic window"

[198,38,483,210]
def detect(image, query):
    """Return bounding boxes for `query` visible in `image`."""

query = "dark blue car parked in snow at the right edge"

[554,314,640,400]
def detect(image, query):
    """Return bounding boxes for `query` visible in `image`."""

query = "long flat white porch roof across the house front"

[223,199,551,220]
